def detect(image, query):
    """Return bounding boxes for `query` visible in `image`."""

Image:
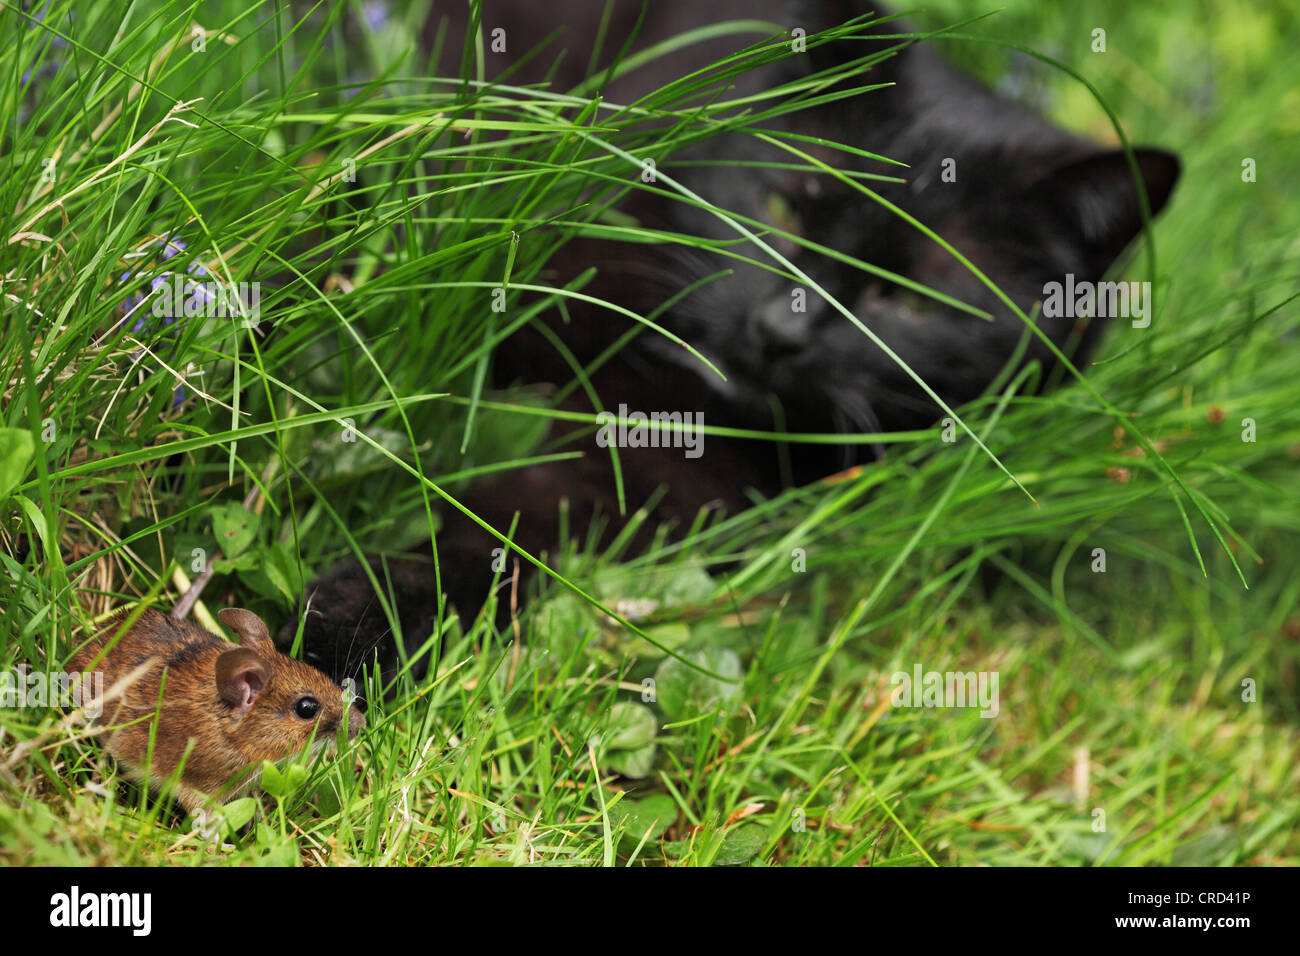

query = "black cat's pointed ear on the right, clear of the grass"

[1035,147,1182,276]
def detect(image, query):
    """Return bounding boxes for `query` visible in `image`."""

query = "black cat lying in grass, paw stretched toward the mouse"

[282,0,1179,679]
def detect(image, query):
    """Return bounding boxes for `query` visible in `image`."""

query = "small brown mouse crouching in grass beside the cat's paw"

[70,607,365,813]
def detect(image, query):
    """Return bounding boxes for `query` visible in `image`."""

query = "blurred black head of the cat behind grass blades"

[616,47,1179,444]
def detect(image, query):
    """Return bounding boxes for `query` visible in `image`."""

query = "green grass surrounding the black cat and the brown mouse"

[0,0,1300,865]
